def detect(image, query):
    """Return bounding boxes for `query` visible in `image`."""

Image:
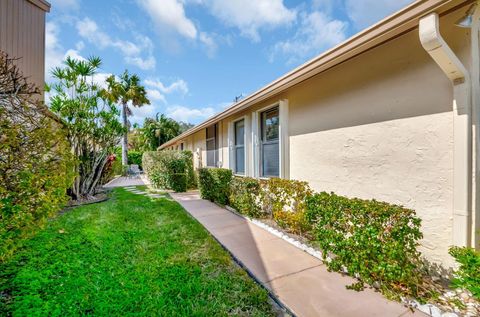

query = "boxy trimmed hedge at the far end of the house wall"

[142,150,195,192]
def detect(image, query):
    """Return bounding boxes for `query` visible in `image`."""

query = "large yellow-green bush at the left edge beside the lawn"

[0,52,74,262]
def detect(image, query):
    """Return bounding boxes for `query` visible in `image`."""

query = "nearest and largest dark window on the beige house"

[260,107,280,177]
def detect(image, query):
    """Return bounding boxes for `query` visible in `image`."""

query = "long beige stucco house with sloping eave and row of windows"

[161,0,480,266]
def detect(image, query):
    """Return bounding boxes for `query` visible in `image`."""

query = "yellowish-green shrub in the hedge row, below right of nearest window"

[261,178,312,234]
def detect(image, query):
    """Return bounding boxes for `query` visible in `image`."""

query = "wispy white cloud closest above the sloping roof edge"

[271,11,347,63]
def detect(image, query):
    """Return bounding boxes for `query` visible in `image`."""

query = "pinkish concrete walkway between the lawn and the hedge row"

[171,192,426,317]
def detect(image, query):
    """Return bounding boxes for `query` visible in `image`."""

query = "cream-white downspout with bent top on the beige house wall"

[419,13,472,246]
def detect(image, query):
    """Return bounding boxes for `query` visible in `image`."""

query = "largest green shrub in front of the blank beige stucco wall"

[305,192,422,296]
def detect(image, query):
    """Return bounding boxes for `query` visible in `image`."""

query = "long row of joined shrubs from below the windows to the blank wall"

[225,177,423,297]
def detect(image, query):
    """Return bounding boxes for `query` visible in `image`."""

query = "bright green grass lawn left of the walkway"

[0,189,273,316]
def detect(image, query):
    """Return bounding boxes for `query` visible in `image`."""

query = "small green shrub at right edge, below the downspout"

[449,247,480,299]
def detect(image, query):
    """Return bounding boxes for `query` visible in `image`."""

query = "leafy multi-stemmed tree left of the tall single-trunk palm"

[47,57,125,199]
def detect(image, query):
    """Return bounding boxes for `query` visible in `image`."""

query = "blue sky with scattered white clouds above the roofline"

[46,0,412,124]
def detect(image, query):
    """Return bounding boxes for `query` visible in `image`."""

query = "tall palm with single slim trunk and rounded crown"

[103,70,150,165]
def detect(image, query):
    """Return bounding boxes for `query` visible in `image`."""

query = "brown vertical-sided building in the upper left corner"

[0,0,50,95]
